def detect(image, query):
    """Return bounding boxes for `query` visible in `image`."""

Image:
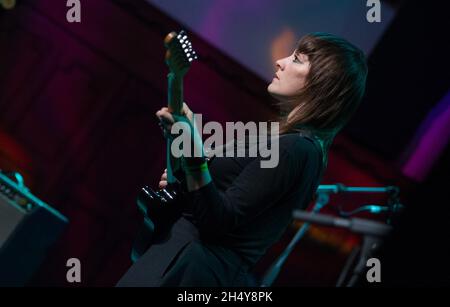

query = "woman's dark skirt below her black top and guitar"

[117,217,255,287]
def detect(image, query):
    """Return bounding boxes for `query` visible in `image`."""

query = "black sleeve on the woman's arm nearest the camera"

[185,138,312,234]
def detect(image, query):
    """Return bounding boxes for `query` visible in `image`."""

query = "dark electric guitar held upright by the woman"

[131,31,197,261]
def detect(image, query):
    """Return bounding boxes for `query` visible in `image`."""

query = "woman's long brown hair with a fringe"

[278,32,367,166]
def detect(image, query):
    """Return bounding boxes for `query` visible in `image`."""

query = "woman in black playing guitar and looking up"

[118,33,367,286]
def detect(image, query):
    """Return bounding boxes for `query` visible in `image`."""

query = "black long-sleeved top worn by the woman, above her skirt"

[188,134,322,266]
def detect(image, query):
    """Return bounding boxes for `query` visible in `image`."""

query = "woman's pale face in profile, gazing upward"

[267,52,310,101]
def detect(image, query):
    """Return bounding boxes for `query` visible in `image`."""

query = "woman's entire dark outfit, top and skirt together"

[118,134,322,286]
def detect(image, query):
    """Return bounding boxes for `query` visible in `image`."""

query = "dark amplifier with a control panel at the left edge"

[0,171,68,287]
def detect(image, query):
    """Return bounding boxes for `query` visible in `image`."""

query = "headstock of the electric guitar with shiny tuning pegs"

[164,30,198,77]
